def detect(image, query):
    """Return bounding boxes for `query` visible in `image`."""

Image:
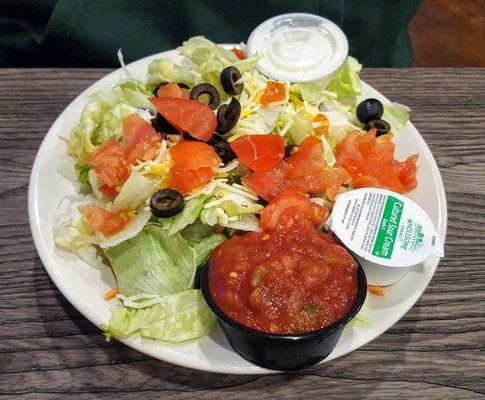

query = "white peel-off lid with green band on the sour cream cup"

[330,188,443,267]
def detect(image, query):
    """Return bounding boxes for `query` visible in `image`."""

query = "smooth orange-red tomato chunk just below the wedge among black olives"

[169,141,221,169]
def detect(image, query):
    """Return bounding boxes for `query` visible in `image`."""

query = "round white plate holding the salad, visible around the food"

[29,51,447,374]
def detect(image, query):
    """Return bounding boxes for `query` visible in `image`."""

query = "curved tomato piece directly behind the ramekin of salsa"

[261,190,328,229]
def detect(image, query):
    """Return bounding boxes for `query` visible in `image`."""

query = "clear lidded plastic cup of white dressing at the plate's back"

[247,13,348,82]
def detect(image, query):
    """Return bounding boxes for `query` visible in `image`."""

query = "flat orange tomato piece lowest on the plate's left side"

[78,205,130,235]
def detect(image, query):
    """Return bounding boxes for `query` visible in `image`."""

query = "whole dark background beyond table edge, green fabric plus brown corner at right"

[0,0,485,67]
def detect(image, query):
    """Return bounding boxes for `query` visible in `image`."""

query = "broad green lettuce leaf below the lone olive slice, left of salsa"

[105,224,196,296]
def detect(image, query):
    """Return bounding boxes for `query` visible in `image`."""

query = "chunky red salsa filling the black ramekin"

[209,206,358,334]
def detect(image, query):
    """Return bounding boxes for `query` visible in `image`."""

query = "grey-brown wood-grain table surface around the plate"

[0,69,485,400]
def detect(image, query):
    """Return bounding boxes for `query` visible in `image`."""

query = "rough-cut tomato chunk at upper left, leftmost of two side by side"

[86,137,131,187]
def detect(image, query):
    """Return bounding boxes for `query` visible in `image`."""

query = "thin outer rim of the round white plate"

[28,48,448,375]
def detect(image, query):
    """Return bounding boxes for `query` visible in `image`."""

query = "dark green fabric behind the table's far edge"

[0,0,419,67]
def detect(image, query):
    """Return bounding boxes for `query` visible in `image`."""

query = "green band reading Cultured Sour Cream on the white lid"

[372,196,404,259]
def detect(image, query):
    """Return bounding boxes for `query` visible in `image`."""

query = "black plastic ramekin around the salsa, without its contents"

[200,261,367,371]
